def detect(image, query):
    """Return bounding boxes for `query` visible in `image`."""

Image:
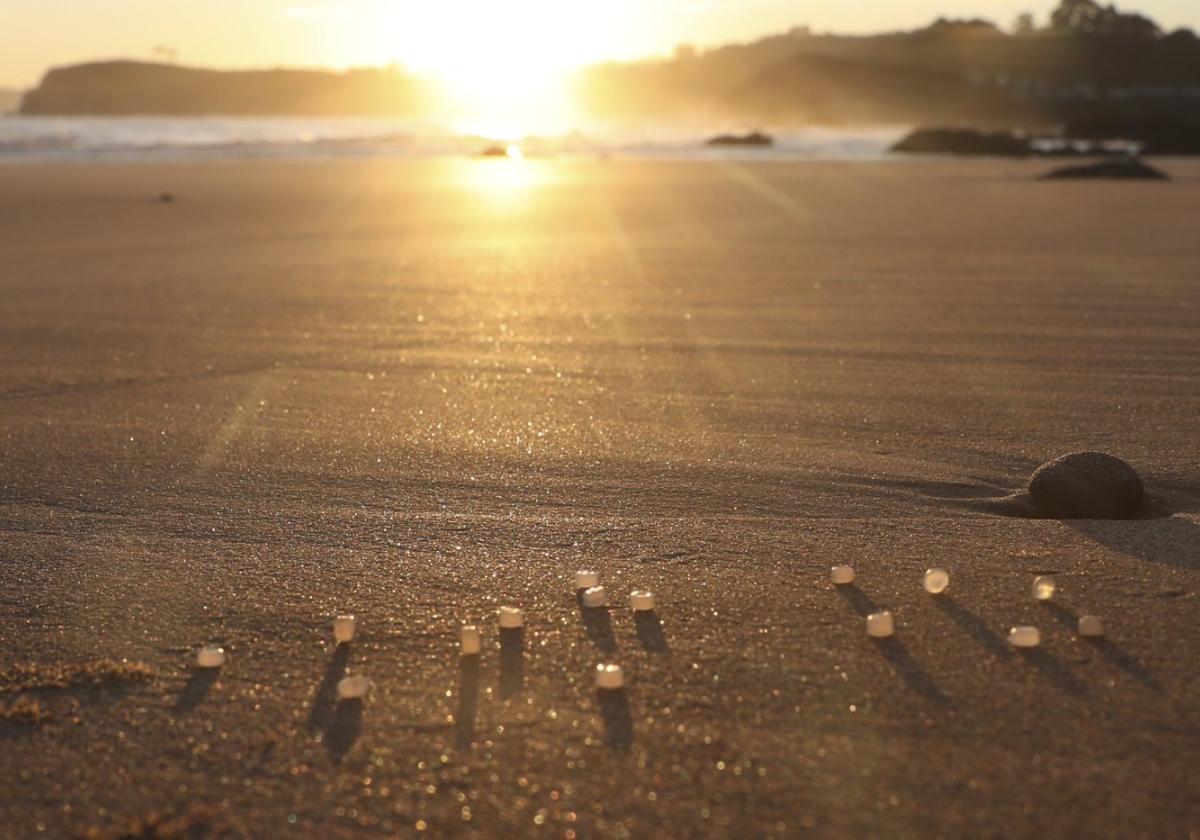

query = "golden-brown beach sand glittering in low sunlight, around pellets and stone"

[0,161,1200,838]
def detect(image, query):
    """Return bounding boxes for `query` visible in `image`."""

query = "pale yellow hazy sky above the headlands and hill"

[0,0,1200,86]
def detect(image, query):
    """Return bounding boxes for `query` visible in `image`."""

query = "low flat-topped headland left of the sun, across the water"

[20,61,427,116]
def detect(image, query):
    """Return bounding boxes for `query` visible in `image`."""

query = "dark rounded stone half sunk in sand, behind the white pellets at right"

[1030,452,1144,520]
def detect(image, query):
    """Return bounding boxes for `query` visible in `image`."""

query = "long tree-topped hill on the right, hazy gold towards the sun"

[580,0,1200,125]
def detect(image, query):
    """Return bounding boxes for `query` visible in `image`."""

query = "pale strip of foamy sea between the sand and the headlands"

[0,115,906,163]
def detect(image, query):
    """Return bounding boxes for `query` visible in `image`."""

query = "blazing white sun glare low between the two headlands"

[370,0,613,140]
